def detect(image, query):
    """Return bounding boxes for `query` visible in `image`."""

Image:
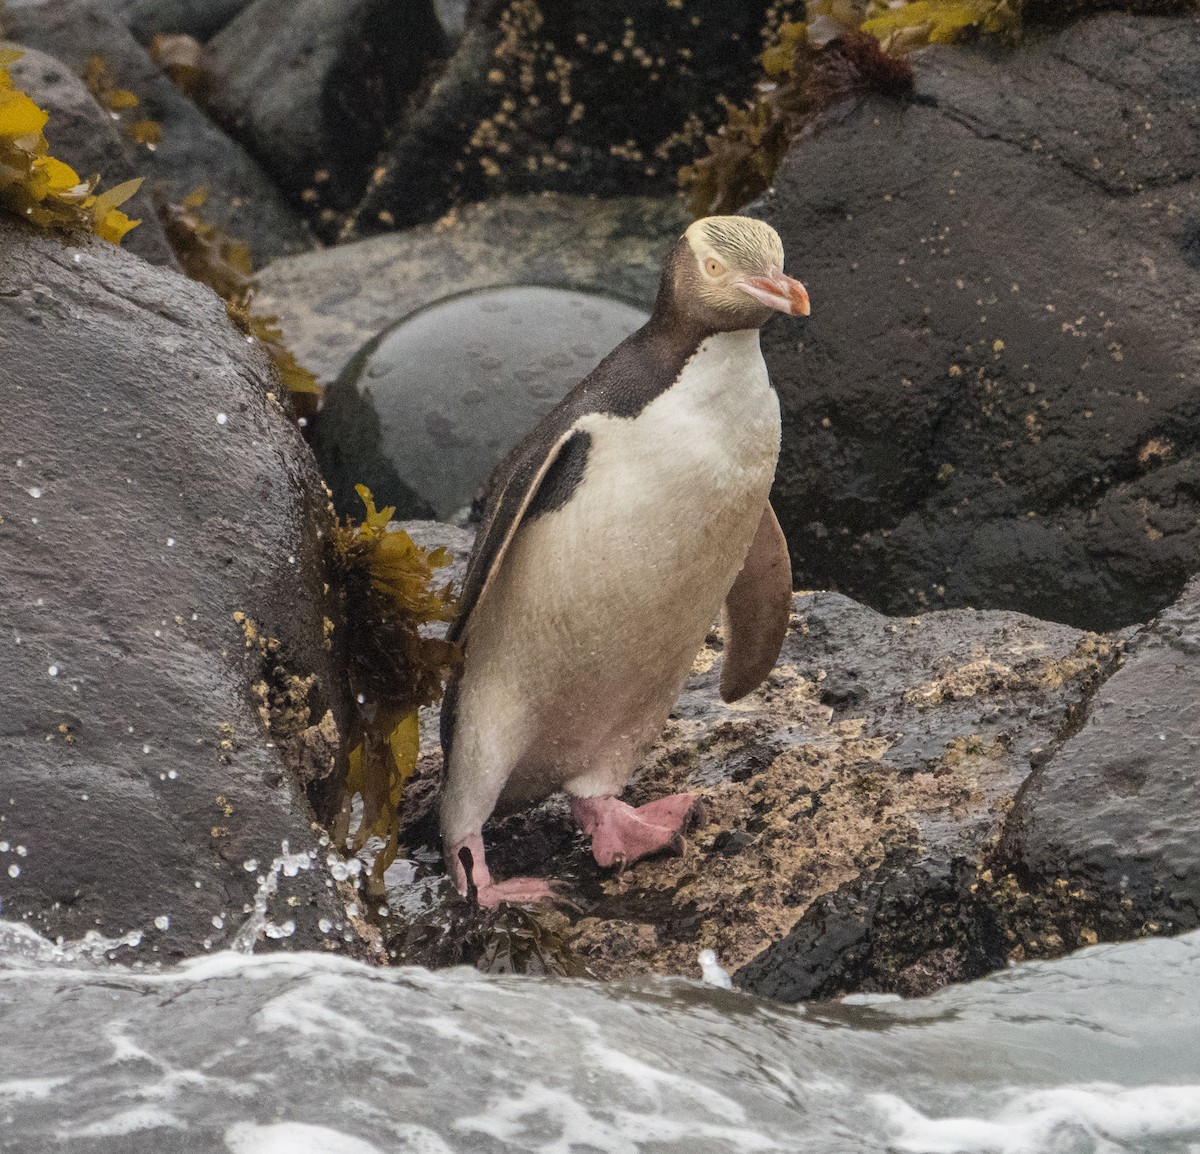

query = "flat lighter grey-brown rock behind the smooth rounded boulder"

[257,196,689,384]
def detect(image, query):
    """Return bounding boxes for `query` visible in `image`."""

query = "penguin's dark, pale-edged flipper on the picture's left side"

[446,421,592,642]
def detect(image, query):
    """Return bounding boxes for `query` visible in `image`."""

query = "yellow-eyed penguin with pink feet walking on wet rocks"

[440,216,809,908]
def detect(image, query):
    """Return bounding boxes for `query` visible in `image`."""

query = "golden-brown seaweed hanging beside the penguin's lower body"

[332,485,461,892]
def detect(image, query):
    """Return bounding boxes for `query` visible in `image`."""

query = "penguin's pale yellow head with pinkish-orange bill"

[664,216,809,332]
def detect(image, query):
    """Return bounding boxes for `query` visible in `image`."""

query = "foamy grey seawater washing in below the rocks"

[0,924,1200,1154]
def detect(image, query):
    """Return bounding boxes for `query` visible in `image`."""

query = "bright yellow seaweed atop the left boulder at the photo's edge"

[0,49,142,245]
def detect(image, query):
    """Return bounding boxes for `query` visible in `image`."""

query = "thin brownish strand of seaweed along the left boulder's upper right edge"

[158,188,323,405]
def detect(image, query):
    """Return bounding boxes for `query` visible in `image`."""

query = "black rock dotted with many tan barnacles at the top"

[349,0,802,236]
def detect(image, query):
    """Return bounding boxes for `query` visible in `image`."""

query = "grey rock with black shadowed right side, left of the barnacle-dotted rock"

[205,0,448,223]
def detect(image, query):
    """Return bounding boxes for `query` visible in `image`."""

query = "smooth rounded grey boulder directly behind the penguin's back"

[312,286,648,519]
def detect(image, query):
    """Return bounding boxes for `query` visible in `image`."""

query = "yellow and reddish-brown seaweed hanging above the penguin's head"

[679,0,1022,216]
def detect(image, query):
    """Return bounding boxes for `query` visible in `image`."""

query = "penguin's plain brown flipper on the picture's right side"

[721,501,792,702]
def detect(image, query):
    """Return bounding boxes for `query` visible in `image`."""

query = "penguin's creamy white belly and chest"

[456,332,779,807]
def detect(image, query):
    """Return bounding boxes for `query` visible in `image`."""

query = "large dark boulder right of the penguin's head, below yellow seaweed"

[751,14,1200,629]
